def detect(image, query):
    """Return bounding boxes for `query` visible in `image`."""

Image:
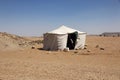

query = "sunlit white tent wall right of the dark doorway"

[75,34,86,49]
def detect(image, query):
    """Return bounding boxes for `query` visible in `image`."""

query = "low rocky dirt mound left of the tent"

[0,32,40,50]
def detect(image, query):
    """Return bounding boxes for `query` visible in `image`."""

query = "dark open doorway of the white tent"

[67,32,78,49]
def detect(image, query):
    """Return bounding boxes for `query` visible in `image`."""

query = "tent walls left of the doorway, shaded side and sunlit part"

[43,34,67,50]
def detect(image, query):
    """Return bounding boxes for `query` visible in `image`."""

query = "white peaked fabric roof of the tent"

[48,25,85,34]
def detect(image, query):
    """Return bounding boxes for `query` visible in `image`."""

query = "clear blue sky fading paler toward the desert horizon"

[0,0,120,36]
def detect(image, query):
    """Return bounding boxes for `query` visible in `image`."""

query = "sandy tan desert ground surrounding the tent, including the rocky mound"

[0,32,120,80]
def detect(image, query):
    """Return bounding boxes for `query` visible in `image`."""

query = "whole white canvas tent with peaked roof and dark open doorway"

[43,25,86,50]
